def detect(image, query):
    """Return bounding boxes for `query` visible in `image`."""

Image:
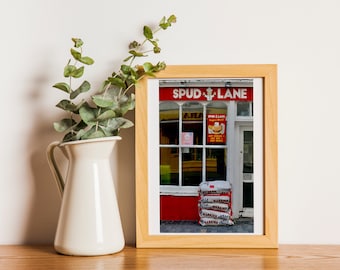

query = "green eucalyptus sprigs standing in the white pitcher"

[53,15,176,142]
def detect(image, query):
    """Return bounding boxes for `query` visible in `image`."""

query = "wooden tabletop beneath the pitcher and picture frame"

[0,245,340,270]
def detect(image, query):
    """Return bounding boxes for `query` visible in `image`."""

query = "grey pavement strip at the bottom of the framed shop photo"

[160,217,254,233]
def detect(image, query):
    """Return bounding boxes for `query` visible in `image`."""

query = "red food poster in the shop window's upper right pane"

[207,114,227,144]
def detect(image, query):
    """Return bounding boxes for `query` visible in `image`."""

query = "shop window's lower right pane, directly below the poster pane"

[206,149,227,181]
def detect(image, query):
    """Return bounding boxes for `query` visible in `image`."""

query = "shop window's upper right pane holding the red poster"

[206,102,227,144]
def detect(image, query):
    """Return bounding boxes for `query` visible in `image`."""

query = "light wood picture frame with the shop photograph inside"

[135,64,278,248]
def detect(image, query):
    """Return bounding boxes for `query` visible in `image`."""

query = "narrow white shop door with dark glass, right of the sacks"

[240,127,254,217]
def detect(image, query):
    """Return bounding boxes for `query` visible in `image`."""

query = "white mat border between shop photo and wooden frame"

[147,78,264,235]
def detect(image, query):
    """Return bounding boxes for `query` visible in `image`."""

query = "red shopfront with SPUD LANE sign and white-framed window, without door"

[159,80,253,221]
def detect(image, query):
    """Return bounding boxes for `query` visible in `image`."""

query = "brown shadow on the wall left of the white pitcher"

[22,74,61,244]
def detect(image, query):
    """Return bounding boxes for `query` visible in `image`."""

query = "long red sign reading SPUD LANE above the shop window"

[159,87,253,101]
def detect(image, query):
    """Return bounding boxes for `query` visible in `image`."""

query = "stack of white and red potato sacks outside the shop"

[198,180,234,226]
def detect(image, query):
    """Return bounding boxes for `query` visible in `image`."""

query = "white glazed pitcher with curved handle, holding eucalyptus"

[47,136,125,256]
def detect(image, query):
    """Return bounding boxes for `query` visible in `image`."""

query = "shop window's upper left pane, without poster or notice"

[159,102,179,145]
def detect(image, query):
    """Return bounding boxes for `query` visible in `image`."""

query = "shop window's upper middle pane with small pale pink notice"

[182,102,203,145]
